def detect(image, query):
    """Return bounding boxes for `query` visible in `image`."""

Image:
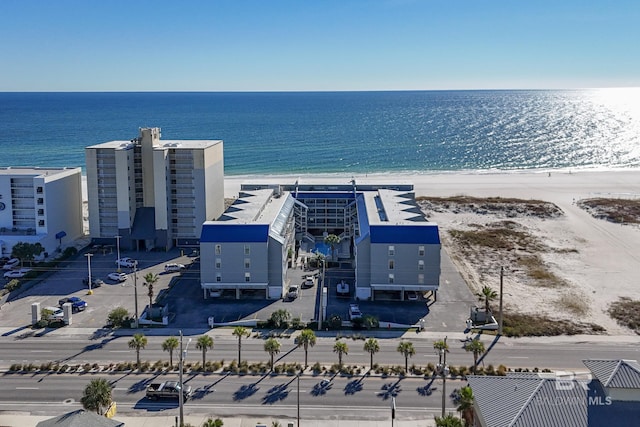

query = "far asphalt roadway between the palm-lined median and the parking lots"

[0,336,640,369]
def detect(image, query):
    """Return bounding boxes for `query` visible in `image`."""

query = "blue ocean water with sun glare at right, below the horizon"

[0,89,640,175]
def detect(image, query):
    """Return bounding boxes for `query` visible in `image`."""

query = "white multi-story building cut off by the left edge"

[0,167,83,256]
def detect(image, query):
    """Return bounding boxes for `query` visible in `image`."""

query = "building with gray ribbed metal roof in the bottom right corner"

[467,360,640,427]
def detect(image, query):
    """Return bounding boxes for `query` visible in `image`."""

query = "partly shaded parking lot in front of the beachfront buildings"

[0,244,475,332]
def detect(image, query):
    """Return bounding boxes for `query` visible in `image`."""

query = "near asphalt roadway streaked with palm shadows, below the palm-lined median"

[0,374,464,420]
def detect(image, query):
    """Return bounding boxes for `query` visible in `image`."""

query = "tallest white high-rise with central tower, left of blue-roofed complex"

[85,128,224,250]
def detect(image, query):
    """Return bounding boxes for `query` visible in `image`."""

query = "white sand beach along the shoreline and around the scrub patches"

[225,170,640,335]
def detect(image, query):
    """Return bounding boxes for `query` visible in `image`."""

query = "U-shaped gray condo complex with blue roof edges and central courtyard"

[200,181,440,299]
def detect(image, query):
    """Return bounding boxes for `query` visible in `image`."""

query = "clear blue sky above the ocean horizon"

[0,0,640,91]
